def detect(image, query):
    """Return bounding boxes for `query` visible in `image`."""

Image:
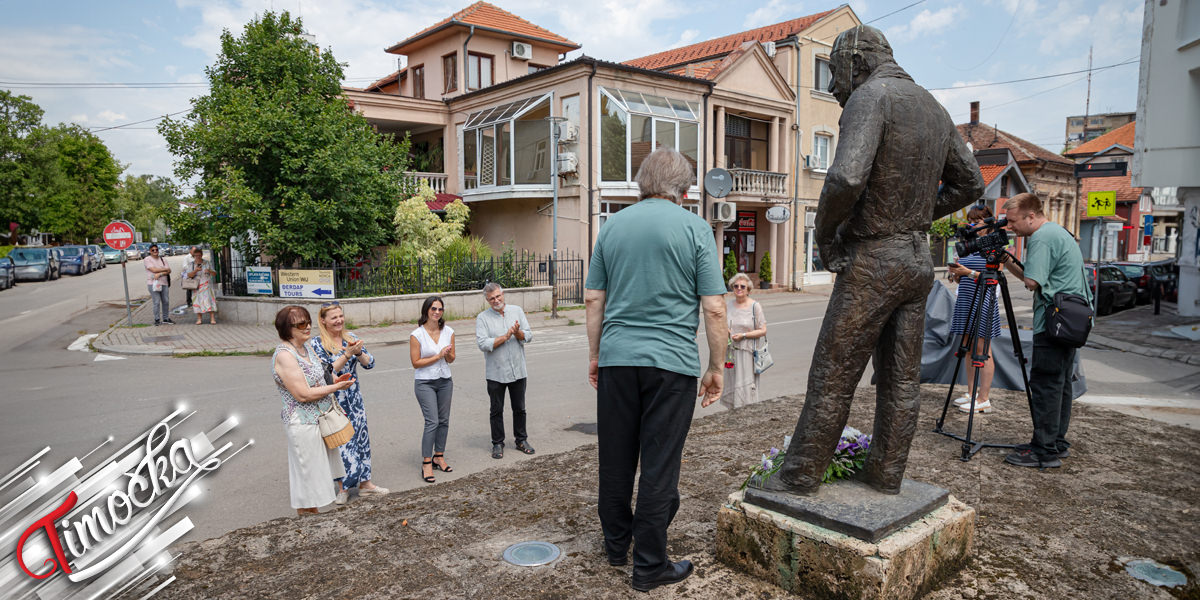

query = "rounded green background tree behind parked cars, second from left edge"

[31,124,122,244]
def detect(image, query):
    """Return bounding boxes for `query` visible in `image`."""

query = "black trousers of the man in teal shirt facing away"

[596,367,696,574]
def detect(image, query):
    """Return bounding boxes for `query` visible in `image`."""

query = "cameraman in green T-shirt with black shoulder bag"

[1004,193,1087,468]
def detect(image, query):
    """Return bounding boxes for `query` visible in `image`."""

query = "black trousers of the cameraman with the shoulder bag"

[1030,332,1075,457]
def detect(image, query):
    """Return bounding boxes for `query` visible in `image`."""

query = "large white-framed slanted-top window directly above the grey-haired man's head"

[600,88,700,182]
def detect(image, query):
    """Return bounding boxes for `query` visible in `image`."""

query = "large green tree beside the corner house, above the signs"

[158,12,412,264]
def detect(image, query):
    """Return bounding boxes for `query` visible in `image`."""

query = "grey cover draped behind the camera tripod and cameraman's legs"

[920,281,1087,398]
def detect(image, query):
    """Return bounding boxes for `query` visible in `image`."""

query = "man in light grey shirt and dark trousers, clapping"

[475,282,534,458]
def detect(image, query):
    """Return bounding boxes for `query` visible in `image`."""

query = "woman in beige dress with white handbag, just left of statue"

[721,272,767,408]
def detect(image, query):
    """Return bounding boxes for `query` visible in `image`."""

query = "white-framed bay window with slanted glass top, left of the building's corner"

[461,94,551,190]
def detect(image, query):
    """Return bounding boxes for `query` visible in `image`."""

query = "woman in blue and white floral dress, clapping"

[308,300,389,504]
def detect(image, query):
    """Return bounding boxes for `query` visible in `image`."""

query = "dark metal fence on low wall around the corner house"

[218,251,583,306]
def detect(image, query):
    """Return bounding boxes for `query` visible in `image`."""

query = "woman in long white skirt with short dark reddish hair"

[271,306,354,515]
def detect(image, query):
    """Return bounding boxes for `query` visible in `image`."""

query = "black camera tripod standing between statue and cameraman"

[934,250,1033,462]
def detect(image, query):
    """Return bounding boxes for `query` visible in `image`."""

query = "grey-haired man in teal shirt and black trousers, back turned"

[583,149,730,592]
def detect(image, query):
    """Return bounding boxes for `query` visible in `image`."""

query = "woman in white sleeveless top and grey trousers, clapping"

[408,296,455,484]
